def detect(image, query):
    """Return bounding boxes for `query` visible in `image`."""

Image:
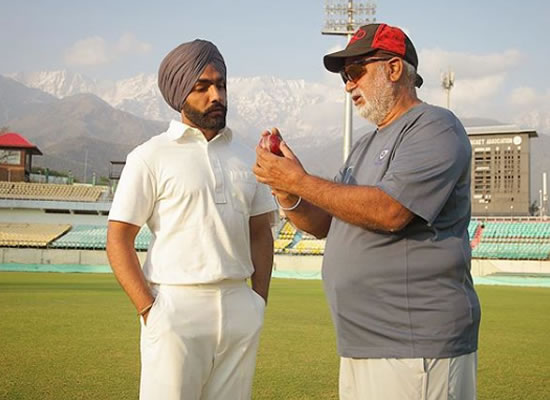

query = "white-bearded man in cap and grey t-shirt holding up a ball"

[254,24,480,400]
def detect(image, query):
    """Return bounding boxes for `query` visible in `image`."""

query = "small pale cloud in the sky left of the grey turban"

[65,33,152,66]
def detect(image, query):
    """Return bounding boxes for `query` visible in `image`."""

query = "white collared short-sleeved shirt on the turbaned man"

[109,121,277,284]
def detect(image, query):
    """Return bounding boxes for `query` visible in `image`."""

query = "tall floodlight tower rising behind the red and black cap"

[321,0,376,161]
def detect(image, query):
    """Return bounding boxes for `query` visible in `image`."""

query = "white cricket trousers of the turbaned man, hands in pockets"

[140,280,265,400]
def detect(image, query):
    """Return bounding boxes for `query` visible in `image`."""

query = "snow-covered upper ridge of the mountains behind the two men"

[9,71,365,149]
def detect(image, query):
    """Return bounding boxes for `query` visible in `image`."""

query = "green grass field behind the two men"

[0,272,550,400]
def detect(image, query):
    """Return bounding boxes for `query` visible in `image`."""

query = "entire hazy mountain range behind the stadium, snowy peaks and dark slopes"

[0,71,550,200]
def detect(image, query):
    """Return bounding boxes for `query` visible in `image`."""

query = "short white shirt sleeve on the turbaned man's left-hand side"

[109,153,156,226]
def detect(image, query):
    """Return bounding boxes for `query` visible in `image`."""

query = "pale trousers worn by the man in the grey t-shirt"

[339,352,477,400]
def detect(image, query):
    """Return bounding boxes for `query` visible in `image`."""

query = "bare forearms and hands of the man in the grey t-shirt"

[253,143,414,233]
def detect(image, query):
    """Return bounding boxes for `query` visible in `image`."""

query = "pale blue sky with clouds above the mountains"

[0,0,550,126]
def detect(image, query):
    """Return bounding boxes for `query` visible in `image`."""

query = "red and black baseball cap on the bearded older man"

[323,24,424,87]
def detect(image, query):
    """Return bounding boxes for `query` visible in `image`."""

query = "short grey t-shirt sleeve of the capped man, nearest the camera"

[377,120,470,224]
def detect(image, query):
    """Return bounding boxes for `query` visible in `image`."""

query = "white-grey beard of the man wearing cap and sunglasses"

[357,68,396,126]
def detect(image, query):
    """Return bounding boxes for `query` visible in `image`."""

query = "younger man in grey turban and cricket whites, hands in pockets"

[107,40,276,400]
